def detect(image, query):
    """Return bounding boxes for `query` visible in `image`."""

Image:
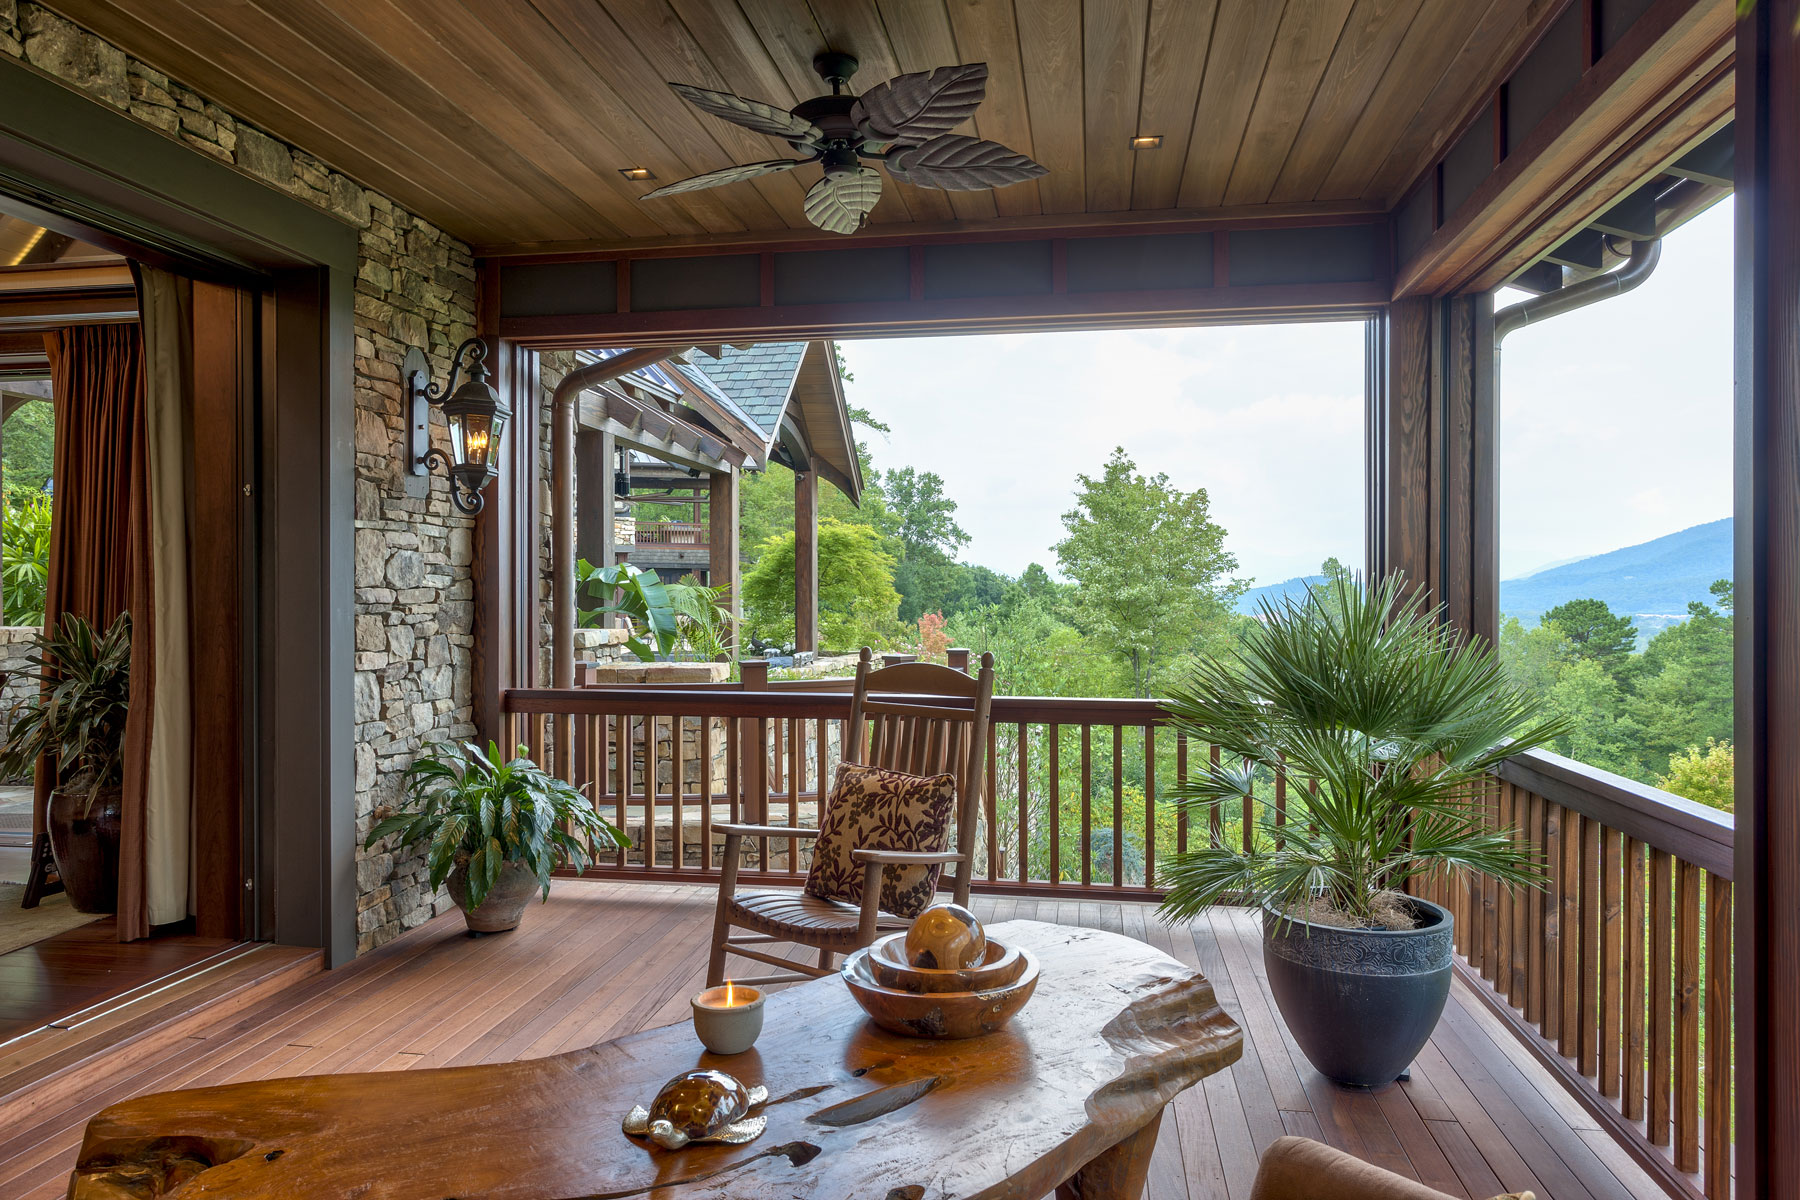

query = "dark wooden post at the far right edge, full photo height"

[1733,0,1800,1196]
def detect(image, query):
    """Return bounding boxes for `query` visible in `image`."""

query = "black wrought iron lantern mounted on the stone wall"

[400,338,513,516]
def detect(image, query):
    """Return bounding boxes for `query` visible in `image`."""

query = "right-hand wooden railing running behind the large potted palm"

[1415,752,1732,1200]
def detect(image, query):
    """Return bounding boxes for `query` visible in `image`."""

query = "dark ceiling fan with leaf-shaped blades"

[641,50,1046,234]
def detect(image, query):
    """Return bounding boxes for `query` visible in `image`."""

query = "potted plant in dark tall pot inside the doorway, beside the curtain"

[0,613,131,912]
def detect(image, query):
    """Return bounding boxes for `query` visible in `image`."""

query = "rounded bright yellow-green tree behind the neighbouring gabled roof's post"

[743,518,902,649]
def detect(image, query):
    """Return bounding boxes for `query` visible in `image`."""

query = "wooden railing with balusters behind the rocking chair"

[504,662,1287,900]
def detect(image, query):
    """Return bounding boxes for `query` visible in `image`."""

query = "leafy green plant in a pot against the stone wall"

[364,741,628,934]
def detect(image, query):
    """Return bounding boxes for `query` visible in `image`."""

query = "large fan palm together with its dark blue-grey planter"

[1163,576,1562,1087]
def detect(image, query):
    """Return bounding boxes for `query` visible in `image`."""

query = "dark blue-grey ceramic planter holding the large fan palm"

[1262,896,1453,1087]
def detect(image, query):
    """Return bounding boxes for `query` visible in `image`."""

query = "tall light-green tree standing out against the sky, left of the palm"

[1057,448,1247,696]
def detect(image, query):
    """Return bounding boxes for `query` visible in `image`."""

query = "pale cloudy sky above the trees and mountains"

[844,203,1732,583]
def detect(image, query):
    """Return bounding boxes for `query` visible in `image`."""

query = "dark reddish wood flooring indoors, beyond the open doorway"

[0,918,241,1043]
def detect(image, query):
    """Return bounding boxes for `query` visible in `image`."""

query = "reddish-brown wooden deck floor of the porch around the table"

[0,882,1663,1200]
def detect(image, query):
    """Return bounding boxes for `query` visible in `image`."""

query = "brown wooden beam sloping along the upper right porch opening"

[1393,0,1732,297]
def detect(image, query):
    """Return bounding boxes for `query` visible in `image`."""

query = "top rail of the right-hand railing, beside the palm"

[1498,750,1735,880]
